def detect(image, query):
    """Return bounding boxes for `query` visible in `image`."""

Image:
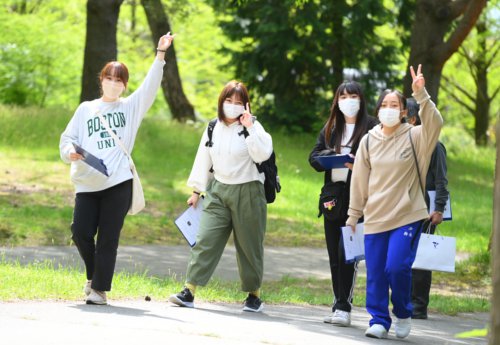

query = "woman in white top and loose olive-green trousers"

[169,81,273,312]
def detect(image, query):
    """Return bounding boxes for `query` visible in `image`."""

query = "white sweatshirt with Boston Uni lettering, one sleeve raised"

[59,59,165,193]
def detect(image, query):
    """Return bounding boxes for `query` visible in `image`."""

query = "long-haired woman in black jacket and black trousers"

[309,81,378,326]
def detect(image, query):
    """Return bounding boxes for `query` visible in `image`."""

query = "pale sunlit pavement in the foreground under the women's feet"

[0,301,486,345]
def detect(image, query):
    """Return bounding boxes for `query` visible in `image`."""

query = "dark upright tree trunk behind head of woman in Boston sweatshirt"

[80,0,123,102]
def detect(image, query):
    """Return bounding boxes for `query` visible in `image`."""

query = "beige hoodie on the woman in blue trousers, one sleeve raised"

[346,89,443,234]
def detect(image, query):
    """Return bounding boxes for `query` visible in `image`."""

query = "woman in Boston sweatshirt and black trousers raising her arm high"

[59,33,173,304]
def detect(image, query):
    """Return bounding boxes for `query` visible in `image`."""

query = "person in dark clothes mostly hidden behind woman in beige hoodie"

[407,98,449,319]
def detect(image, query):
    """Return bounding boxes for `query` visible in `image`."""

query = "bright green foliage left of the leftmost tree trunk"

[0,0,85,106]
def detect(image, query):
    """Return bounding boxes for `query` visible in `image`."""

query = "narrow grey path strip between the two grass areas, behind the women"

[0,245,336,280]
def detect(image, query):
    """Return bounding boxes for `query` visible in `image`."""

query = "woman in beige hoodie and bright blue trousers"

[346,65,443,338]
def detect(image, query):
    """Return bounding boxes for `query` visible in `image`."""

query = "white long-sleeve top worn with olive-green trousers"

[187,121,273,192]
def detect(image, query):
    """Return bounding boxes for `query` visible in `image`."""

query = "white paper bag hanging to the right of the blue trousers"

[412,232,456,272]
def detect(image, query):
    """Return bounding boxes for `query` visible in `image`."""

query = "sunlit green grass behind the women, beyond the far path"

[0,105,495,254]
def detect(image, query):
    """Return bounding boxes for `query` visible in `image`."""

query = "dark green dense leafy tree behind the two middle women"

[211,0,397,131]
